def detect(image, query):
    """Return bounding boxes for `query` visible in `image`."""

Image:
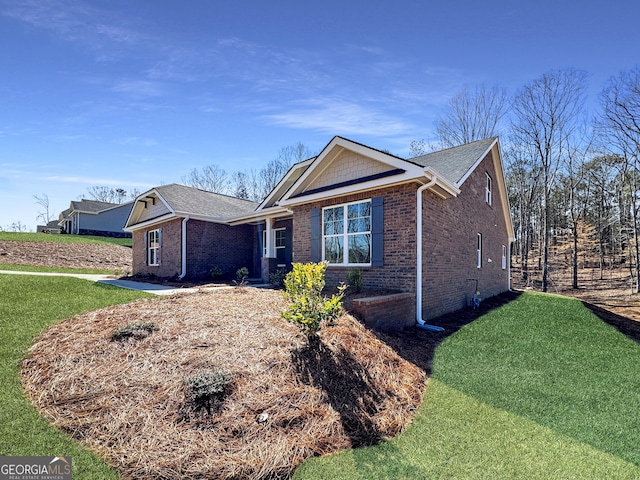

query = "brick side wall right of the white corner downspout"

[422,153,508,320]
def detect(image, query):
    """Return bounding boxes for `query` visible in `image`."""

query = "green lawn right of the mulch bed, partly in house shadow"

[294,293,640,479]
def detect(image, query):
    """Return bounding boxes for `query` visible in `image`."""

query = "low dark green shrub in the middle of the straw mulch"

[183,369,233,413]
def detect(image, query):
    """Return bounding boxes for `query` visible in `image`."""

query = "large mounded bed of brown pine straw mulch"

[21,288,426,479]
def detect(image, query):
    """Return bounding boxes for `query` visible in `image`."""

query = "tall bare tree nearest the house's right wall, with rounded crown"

[511,69,586,292]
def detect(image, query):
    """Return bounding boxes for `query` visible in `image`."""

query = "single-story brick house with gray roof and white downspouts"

[126,137,514,325]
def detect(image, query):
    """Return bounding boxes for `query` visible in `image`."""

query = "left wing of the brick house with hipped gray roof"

[125,183,257,279]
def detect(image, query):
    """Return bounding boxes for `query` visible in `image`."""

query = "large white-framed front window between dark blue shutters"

[322,200,371,265]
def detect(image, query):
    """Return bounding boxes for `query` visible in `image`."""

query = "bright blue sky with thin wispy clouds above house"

[0,0,640,230]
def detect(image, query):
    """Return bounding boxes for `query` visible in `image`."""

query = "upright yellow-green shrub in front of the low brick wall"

[280,262,347,340]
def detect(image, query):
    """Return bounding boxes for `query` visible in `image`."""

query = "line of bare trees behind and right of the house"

[424,67,640,293]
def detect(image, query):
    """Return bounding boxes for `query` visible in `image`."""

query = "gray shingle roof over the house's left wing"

[155,183,258,218]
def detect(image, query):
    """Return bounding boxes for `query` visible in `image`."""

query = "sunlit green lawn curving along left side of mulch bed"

[0,275,150,480]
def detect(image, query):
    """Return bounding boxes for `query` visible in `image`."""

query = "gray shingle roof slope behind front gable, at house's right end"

[407,137,497,185]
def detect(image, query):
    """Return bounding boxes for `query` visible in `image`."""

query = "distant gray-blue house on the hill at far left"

[58,199,133,237]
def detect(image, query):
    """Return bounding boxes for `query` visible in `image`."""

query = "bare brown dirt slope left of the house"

[0,240,132,272]
